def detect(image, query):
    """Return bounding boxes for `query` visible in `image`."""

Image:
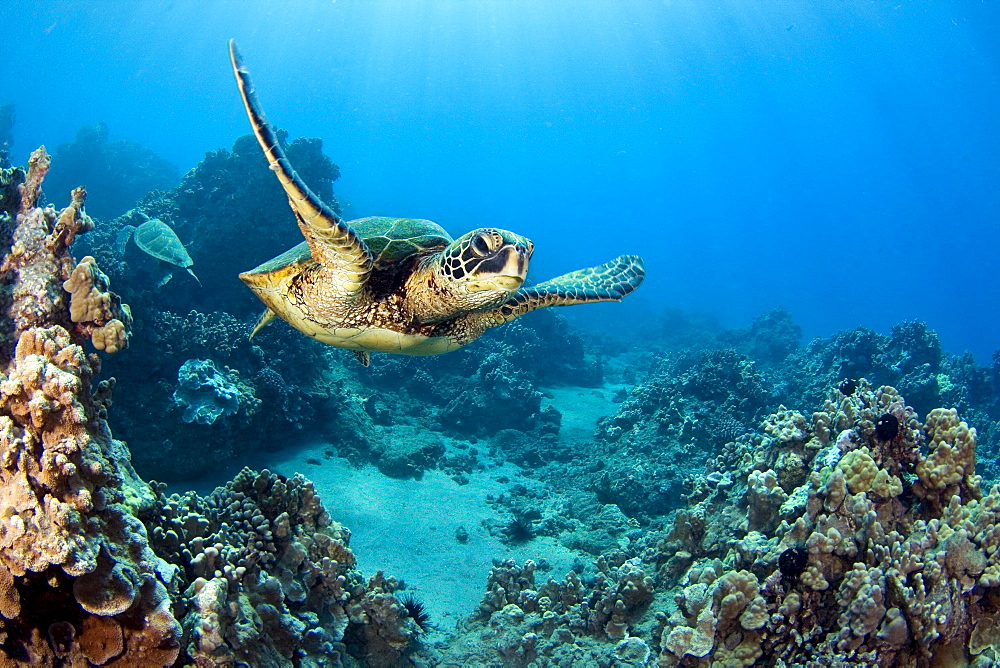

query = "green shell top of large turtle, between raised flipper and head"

[348,216,452,269]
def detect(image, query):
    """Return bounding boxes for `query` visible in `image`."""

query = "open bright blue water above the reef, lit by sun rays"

[0,0,1000,363]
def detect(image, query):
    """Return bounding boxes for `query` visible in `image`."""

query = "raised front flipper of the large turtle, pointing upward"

[229,40,372,299]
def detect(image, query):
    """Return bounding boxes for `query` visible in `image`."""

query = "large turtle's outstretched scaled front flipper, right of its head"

[493,255,646,326]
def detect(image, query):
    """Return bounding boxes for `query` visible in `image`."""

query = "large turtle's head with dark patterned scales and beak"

[438,227,535,298]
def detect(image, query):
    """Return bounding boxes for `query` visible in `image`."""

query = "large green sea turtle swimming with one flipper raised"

[229,40,645,364]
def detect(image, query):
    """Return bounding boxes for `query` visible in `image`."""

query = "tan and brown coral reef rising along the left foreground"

[0,149,418,667]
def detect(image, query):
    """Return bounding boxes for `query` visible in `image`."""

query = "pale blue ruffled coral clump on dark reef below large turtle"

[174,359,259,424]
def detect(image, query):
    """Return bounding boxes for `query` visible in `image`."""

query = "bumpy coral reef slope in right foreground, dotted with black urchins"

[434,379,1000,667]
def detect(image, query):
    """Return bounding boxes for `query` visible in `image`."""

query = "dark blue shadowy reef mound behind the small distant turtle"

[76,132,340,320]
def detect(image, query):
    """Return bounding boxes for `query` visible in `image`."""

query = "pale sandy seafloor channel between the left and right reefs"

[168,384,623,643]
